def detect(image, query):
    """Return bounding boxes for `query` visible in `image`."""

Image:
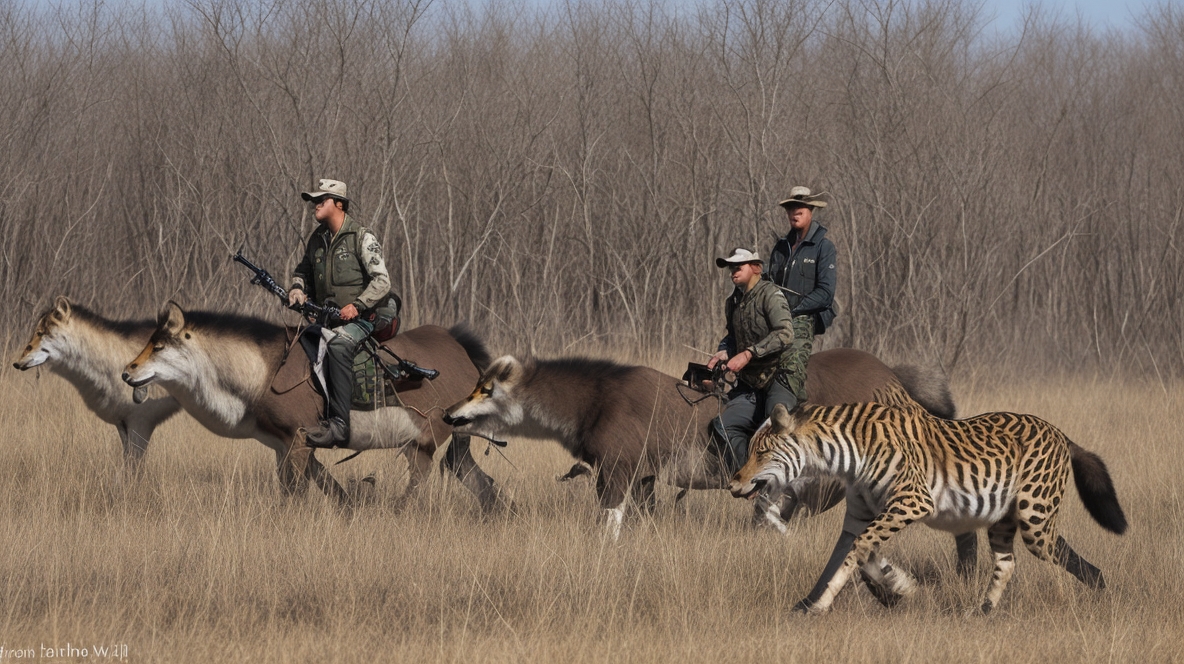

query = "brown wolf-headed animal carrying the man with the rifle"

[123,302,498,510]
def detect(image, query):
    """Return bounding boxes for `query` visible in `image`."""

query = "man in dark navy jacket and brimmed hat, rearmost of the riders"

[762,187,838,410]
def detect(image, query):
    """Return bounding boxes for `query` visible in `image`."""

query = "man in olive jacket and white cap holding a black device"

[707,247,804,475]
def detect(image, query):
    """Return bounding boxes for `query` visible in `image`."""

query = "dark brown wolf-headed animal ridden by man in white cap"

[444,348,974,561]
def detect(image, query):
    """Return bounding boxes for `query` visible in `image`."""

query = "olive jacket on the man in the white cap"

[719,279,793,388]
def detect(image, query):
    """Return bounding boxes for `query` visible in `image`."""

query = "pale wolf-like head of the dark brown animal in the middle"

[444,355,527,439]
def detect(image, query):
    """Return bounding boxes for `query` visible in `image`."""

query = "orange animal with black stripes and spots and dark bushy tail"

[729,404,1127,613]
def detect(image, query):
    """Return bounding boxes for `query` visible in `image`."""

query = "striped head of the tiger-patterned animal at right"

[728,404,805,498]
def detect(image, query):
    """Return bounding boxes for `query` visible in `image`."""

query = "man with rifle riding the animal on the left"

[288,180,391,447]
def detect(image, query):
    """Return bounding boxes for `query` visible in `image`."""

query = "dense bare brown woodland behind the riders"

[0,0,1184,381]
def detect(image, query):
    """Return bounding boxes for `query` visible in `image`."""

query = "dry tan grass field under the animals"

[0,362,1184,663]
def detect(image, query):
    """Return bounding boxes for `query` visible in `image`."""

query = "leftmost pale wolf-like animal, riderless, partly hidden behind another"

[12,295,181,466]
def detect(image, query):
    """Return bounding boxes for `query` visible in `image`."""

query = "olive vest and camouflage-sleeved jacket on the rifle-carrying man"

[292,214,391,311]
